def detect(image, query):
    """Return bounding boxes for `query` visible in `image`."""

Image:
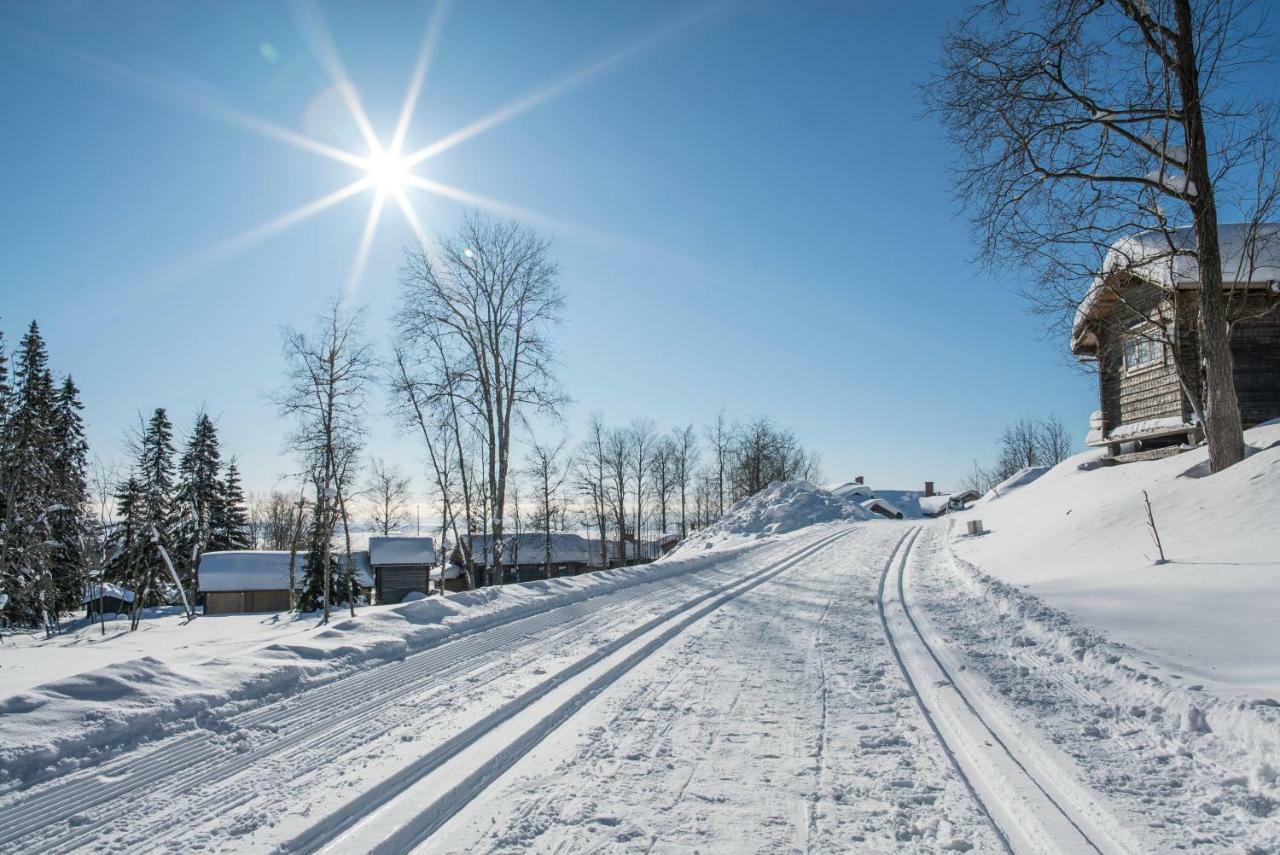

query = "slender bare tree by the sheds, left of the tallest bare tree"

[275,298,375,623]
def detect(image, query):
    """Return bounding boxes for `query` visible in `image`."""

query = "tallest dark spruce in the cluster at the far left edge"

[0,321,56,627]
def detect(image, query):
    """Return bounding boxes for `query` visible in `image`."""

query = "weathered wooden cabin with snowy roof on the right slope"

[1071,225,1280,462]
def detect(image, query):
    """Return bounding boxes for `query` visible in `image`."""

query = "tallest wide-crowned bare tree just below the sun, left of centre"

[397,212,563,583]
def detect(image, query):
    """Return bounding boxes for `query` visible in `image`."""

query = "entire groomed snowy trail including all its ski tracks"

[10,511,1270,854]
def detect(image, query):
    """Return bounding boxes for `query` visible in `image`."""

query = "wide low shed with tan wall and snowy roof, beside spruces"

[196,549,307,614]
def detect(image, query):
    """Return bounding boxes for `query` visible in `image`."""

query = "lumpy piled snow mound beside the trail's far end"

[689,481,872,548]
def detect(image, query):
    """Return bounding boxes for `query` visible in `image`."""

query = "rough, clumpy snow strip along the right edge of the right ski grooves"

[908,527,1280,854]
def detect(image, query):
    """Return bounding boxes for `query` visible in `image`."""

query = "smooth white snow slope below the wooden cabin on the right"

[955,421,1280,699]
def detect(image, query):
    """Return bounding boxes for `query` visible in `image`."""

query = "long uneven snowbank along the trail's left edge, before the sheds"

[0,535,799,785]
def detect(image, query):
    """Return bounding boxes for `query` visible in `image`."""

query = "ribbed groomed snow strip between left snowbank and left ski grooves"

[0,531,829,851]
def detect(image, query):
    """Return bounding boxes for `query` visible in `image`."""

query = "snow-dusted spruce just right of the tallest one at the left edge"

[49,376,90,612]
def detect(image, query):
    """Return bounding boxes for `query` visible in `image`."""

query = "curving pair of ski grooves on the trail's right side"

[879,527,1117,855]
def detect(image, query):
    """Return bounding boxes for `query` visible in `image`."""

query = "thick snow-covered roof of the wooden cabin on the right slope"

[1071,223,1280,349]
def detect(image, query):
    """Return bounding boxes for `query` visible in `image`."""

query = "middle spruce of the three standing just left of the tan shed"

[173,412,223,591]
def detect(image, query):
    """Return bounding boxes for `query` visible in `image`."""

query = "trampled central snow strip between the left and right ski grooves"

[420,523,1000,852]
